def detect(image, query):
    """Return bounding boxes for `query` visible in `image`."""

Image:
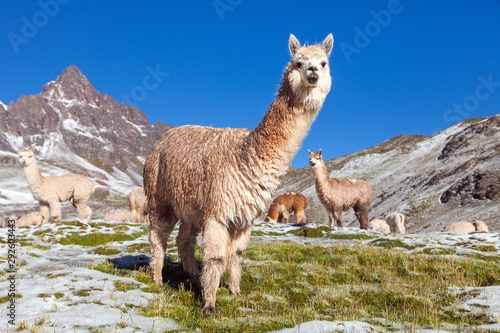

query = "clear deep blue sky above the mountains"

[0,0,500,167]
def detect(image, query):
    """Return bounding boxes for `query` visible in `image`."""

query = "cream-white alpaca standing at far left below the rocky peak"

[19,148,94,223]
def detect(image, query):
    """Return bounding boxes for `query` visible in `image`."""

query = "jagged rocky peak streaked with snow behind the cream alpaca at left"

[0,66,172,217]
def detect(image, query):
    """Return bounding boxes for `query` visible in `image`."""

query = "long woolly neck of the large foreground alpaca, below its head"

[246,69,329,172]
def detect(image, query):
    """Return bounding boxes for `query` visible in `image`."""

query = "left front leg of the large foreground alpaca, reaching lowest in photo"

[200,219,229,314]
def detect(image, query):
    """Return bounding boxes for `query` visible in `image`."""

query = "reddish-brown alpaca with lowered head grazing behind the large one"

[264,192,309,223]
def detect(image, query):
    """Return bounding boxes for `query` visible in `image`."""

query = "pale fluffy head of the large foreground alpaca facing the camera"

[288,34,333,102]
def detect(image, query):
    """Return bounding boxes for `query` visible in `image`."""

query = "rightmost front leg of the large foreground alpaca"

[227,227,252,295]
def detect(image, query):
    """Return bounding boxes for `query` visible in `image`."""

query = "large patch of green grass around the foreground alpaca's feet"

[94,236,500,333]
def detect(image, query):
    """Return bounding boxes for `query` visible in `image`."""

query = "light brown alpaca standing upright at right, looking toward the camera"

[309,149,373,229]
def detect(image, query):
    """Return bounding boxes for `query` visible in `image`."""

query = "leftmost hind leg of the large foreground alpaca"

[149,212,177,287]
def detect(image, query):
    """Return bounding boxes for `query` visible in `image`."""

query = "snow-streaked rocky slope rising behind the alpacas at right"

[279,115,500,233]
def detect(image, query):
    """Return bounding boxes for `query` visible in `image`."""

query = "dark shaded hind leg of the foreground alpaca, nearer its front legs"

[176,221,201,289]
